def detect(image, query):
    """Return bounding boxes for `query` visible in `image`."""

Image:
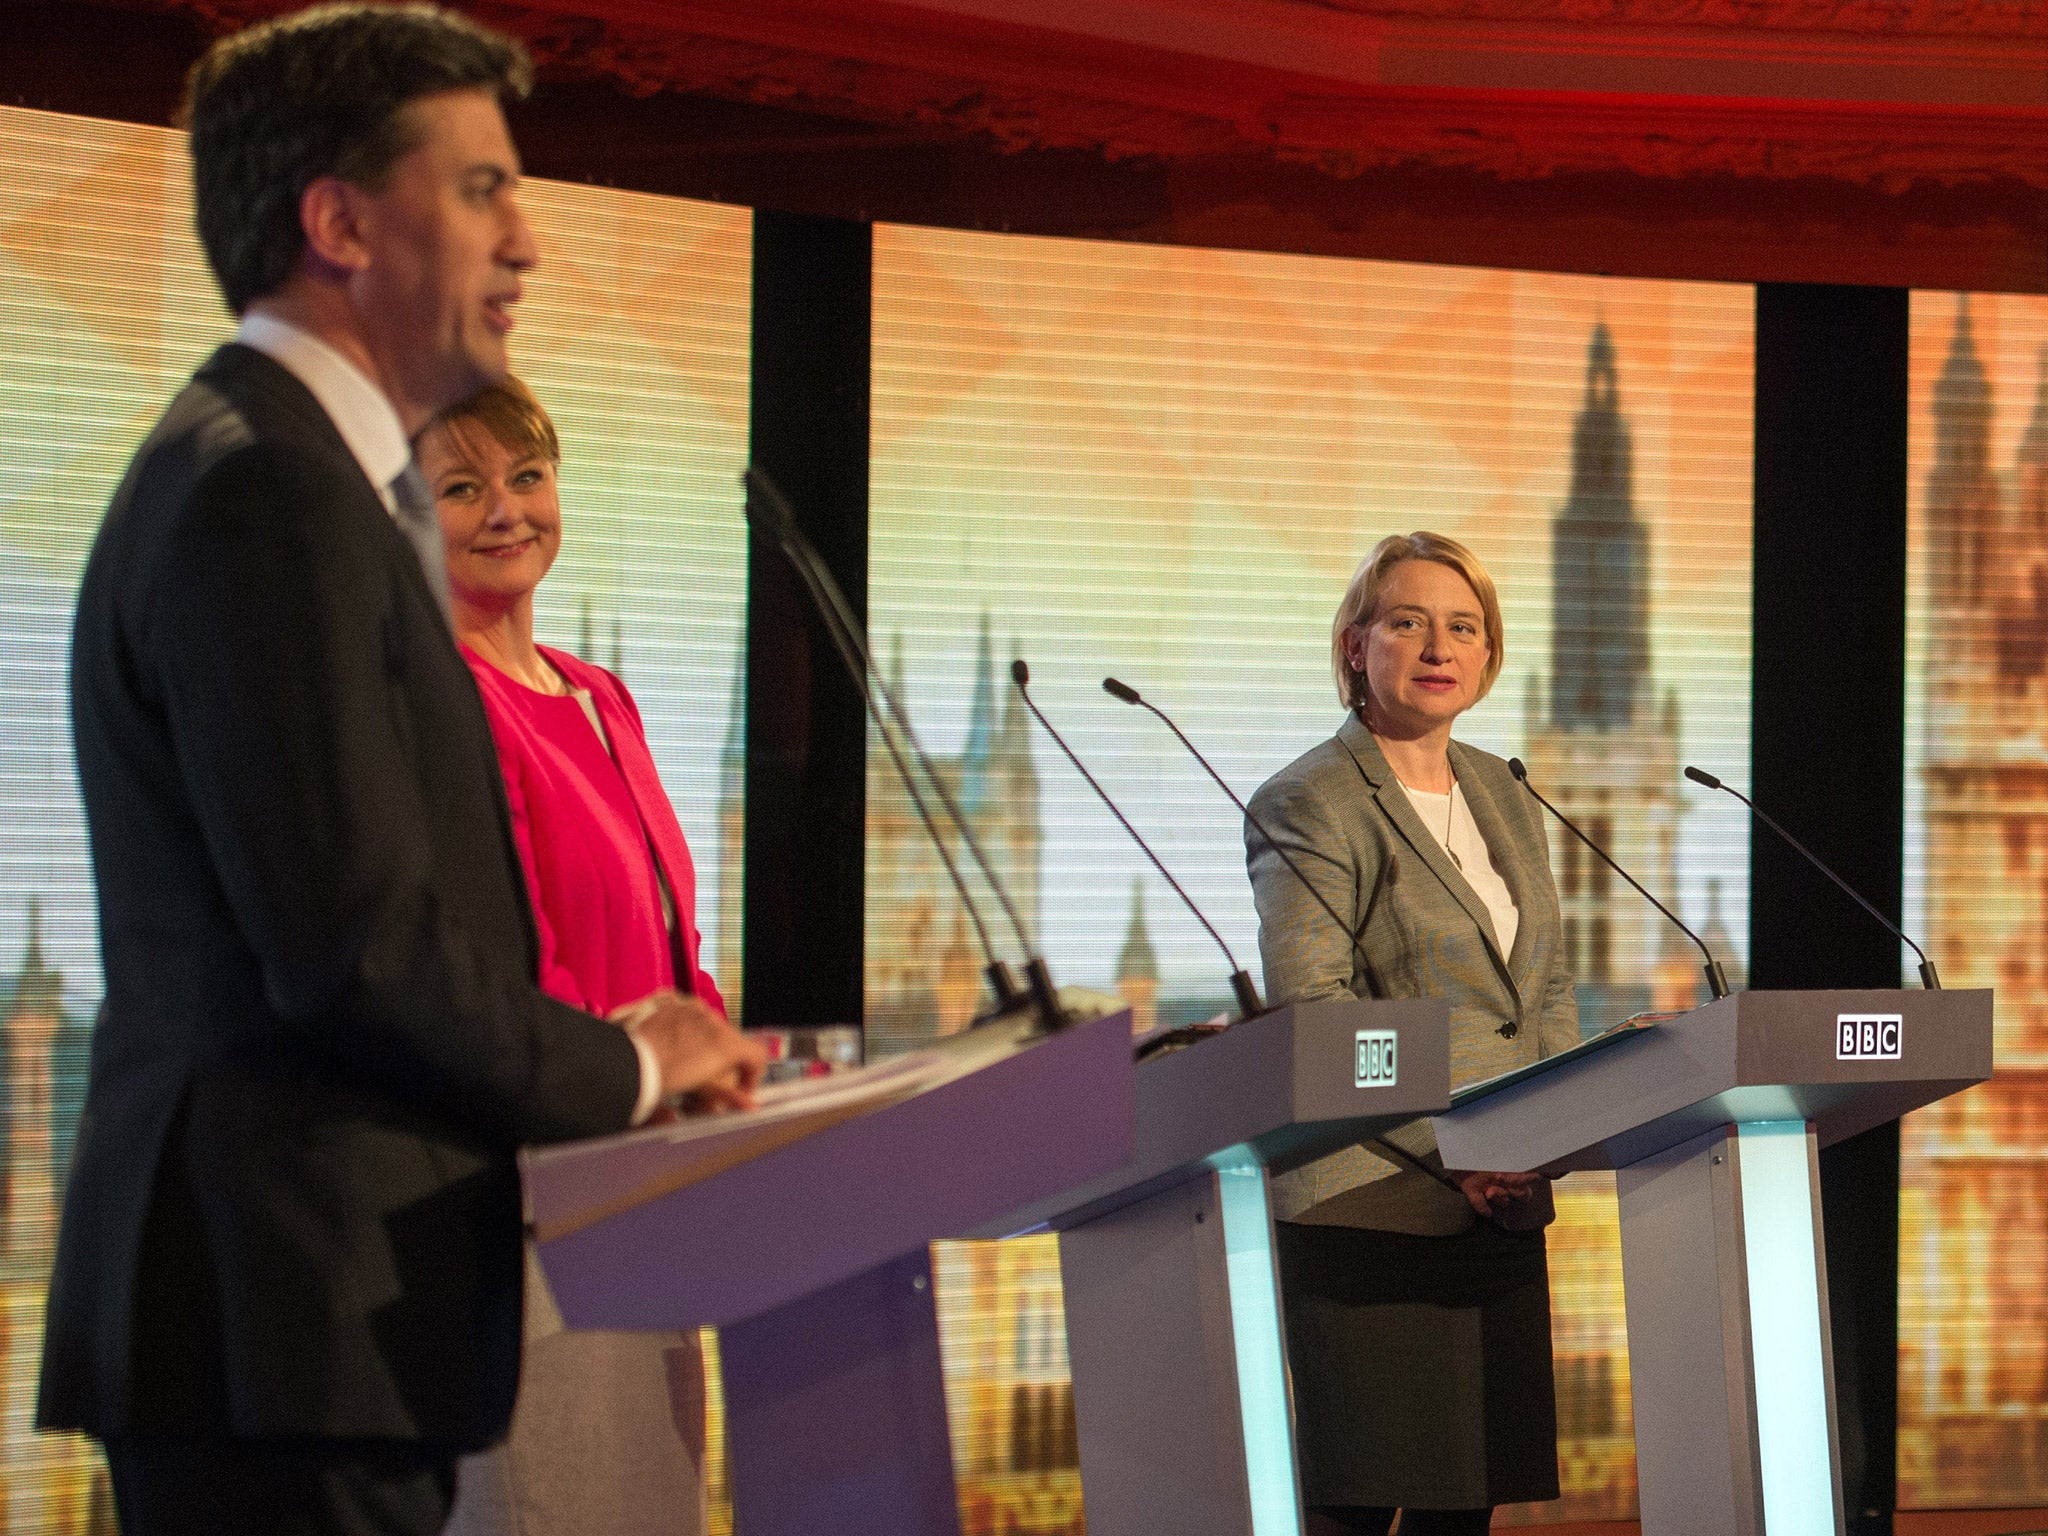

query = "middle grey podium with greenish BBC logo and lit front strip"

[965,999,1450,1536]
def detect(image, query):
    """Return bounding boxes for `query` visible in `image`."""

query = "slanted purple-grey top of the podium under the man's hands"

[522,1012,1133,1329]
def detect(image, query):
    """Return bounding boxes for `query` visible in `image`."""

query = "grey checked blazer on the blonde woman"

[1245,715,1579,1235]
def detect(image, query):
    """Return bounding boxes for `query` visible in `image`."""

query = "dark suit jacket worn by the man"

[39,346,639,1446]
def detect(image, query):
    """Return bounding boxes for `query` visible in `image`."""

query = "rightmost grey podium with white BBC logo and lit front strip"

[1436,991,1993,1536]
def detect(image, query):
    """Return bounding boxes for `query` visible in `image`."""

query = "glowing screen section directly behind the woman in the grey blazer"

[866,227,1753,1530]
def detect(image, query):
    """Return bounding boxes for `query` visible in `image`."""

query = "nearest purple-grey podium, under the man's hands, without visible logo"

[524,1012,1133,1536]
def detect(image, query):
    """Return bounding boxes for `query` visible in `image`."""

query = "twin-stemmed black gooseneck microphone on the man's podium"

[739,465,1071,1032]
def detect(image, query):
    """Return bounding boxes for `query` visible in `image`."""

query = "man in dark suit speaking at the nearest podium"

[39,6,760,1536]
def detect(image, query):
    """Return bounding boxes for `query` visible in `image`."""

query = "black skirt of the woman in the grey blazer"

[1274,1221,1556,1509]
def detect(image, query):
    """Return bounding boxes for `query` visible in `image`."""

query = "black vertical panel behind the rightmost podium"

[1749,285,1907,1532]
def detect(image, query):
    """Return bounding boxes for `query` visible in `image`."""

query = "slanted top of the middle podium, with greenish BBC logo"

[961,997,1450,1237]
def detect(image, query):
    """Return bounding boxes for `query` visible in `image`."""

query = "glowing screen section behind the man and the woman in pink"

[0,109,750,1534]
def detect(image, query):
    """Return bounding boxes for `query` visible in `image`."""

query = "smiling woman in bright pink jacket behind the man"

[416,379,725,1536]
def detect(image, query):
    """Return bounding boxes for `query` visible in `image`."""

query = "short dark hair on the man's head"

[184,4,532,315]
